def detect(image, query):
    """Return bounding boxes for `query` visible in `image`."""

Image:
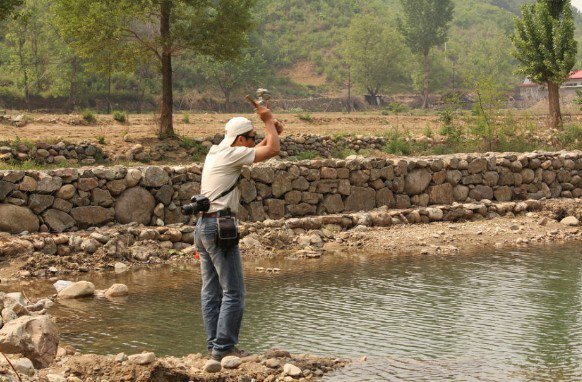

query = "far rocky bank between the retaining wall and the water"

[0,198,582,283]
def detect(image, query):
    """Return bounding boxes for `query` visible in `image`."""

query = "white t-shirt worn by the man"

[200,146,255,214]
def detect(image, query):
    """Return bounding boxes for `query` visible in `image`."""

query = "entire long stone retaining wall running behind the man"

[0,151,582,233]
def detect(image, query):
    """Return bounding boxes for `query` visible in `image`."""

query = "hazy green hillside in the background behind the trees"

[0,0,582,111]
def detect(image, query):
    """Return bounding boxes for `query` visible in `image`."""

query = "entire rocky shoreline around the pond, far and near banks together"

[0,198,582,382]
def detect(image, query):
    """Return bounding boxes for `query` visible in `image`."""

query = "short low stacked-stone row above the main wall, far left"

[0,142,106,165]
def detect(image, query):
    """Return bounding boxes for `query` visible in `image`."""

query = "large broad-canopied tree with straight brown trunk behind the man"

[56,0,255,138]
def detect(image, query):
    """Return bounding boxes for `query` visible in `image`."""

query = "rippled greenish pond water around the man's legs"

[11,245,582,381]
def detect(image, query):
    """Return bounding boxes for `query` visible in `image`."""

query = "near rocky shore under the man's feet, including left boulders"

[0,288,349,382]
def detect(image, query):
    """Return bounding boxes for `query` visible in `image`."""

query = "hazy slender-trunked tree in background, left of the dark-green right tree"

[398,0,453,108]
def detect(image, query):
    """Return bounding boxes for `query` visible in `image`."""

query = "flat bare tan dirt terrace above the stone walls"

[0,111,582,145]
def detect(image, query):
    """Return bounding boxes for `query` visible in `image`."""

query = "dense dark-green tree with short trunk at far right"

[512,0,577,128]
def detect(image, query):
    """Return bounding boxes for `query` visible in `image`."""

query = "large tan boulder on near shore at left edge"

[0,316,59,368]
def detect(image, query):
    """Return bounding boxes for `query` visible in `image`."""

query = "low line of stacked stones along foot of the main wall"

[0,200,579,278]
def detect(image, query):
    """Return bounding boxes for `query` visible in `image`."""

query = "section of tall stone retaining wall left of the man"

[0,166,201,233]
